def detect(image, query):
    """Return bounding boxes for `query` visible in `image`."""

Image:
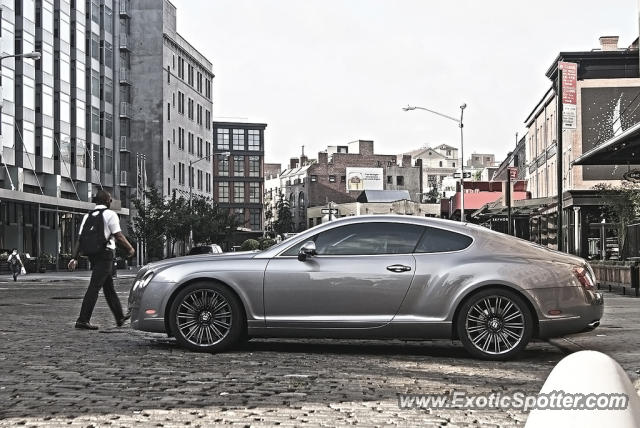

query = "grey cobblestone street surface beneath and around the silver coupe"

[0,278,640,427]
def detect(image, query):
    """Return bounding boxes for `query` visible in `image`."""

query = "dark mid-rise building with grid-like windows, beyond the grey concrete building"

[213,122,267,232]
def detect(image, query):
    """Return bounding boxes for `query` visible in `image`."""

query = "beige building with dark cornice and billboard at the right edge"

[525,37,640,257]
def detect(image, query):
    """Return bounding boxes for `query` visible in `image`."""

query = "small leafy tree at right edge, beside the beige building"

[593,181,640,256]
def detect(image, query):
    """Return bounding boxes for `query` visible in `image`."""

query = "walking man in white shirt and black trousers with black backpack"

[69,190,135,330]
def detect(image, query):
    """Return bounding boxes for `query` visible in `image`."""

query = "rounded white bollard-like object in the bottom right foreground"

[525,351,640,428]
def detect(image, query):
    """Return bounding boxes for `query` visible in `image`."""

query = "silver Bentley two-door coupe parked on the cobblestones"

[129,215,603,360]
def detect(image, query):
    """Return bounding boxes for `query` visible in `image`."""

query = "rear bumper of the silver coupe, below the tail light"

[538,292,604,339]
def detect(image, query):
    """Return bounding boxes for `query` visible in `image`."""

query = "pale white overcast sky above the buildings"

[171,0,638,166]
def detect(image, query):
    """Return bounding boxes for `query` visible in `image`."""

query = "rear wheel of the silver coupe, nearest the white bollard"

[456,288,534,360]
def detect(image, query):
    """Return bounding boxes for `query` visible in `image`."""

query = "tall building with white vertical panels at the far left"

[0,0,128,258]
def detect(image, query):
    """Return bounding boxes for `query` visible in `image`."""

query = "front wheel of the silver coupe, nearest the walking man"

[169,282,246,353]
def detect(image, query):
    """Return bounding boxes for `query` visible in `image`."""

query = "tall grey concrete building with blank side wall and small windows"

[119,0,214,207]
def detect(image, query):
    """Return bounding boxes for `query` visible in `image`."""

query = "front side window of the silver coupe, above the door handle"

[315,223,423,255]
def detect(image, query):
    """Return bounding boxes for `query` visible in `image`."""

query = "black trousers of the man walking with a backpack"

[78,250,123,322]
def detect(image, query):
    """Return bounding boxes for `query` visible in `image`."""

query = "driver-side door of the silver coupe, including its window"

[264,222,423,328]
